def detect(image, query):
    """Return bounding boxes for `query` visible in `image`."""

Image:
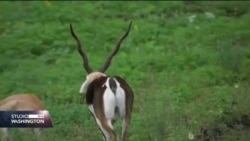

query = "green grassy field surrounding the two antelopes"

[0,1,250,141]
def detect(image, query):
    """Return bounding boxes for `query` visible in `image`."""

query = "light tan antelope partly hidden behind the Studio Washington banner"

[0,94,44,141]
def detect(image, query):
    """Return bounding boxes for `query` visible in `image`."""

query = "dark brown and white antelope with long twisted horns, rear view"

[70,22,134,141]
